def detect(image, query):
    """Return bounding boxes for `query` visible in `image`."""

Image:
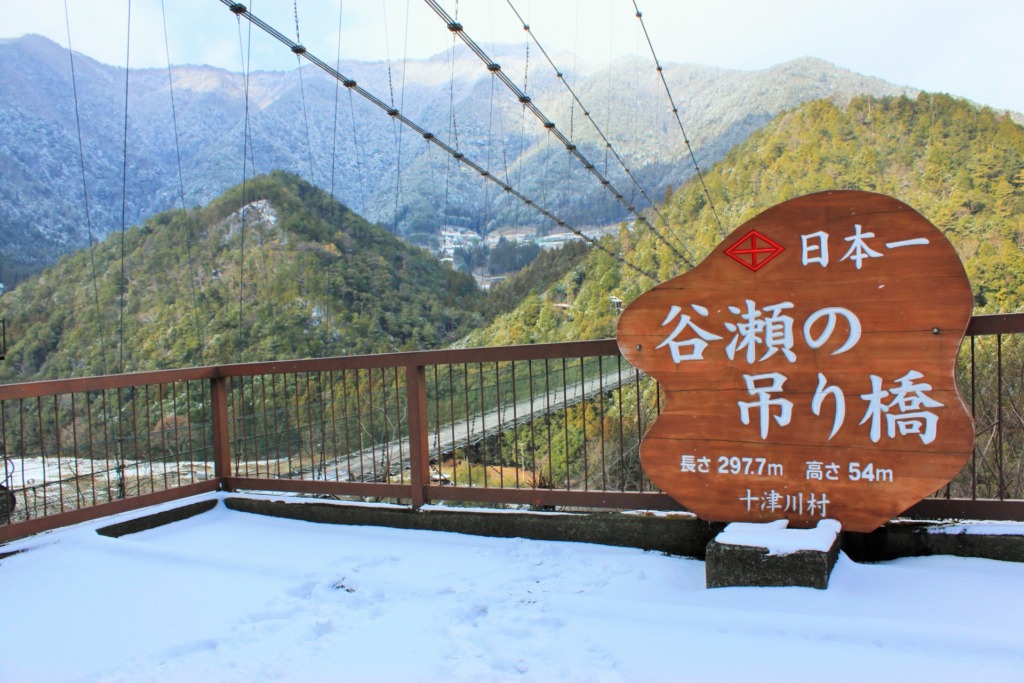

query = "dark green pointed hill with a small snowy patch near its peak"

[0,172,480,381]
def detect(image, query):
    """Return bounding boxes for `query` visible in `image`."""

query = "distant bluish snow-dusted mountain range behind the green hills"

[0,36,915,288]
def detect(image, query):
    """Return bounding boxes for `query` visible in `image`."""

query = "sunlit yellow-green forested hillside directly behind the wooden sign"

[471,93,1024,346]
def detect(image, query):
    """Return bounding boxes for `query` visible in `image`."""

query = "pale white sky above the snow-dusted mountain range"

[0,0,1024,112]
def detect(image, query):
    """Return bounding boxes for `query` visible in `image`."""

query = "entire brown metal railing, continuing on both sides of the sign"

[0,313,1024,542]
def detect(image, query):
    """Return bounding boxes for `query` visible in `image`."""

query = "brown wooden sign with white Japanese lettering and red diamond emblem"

[617,191,974,531]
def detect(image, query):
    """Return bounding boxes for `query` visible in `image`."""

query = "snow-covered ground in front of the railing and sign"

[0,497,1024,683]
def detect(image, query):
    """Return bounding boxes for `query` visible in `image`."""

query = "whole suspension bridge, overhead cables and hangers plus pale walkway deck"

[2,0,721,507]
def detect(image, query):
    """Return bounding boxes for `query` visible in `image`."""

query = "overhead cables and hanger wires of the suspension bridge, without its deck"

[34,0,722,374]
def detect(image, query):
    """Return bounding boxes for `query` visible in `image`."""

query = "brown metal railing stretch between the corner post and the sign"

[220,340,667,509]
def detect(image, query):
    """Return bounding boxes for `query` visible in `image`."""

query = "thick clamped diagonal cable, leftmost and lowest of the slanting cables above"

[220,0,657,281]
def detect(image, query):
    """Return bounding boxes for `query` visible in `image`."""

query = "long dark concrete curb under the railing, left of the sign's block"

[224,497,722,558]
